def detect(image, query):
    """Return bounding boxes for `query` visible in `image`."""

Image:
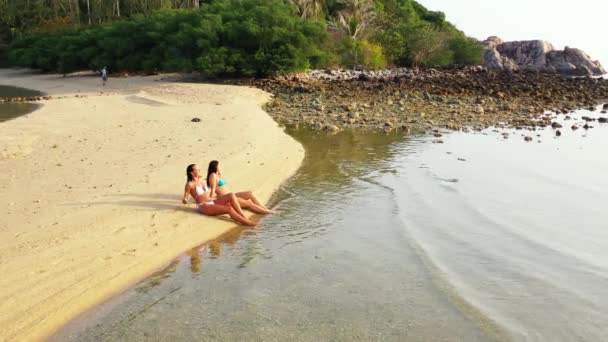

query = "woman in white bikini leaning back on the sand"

[182,164,255,226]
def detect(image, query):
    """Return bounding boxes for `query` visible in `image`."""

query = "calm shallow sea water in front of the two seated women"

[54,106,608,341]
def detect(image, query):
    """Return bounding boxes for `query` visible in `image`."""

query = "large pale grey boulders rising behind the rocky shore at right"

[483,37,606,76]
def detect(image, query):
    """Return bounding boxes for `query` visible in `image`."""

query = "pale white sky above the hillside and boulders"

[417,0,608,68]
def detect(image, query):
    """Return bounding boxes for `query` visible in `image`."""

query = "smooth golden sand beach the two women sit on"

[0,70,304,341]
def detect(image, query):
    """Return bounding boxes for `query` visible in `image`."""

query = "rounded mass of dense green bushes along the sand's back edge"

[9,0,326,76]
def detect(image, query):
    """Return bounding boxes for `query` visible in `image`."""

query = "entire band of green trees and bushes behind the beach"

[0,0,483,76]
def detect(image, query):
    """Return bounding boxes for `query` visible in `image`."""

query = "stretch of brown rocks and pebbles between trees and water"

[253,67,608,133]
